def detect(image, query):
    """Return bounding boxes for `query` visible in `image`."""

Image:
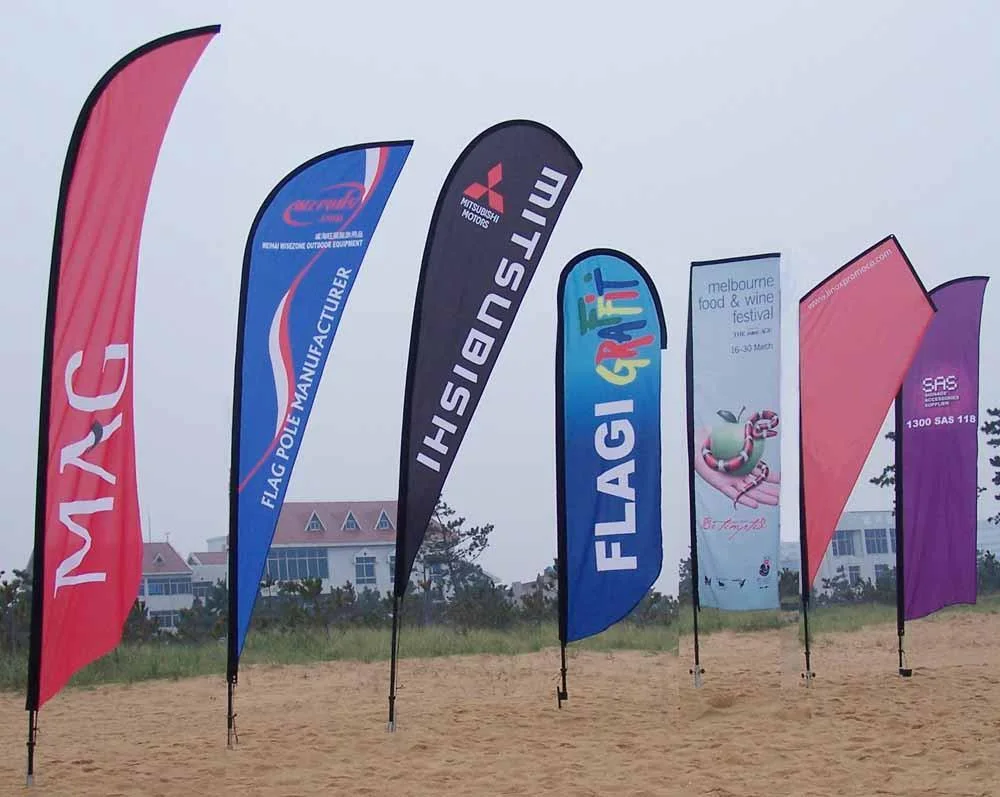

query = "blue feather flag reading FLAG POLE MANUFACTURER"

[228,141,413,681]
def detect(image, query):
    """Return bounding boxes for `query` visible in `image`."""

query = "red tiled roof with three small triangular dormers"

[271,501,396,545]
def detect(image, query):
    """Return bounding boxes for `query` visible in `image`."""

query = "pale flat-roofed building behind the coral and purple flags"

[780,510,1000,589]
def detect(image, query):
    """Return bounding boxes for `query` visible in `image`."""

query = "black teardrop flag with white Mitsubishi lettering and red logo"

[394,120,581,597]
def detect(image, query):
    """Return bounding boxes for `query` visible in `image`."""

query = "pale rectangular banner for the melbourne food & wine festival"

[687,254,781,611]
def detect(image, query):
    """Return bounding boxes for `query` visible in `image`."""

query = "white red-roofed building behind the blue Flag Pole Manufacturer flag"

[204,501,396,593]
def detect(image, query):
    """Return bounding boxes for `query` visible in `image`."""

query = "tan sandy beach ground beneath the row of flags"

[0,613,1000,797]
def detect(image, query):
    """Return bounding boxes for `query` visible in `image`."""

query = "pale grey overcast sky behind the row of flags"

[0,0,1000,592]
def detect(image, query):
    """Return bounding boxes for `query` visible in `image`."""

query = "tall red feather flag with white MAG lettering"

[27,26,219,708]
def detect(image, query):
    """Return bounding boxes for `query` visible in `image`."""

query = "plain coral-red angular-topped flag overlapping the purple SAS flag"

[799,236,935,594]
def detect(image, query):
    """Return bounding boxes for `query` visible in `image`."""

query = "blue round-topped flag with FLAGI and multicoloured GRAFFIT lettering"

[556,249,667,643]
